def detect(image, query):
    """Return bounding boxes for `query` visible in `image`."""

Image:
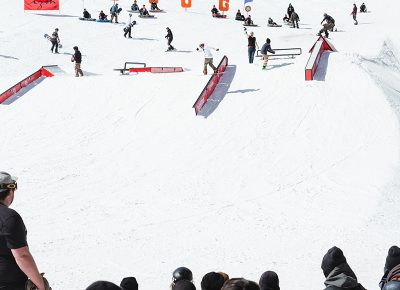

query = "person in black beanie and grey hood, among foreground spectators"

[321,247,365,290]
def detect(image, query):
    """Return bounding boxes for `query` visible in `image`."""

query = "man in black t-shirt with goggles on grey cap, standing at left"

[0,172,48,290]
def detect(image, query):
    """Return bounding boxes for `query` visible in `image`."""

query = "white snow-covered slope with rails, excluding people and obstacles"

[0,0,400,290]
